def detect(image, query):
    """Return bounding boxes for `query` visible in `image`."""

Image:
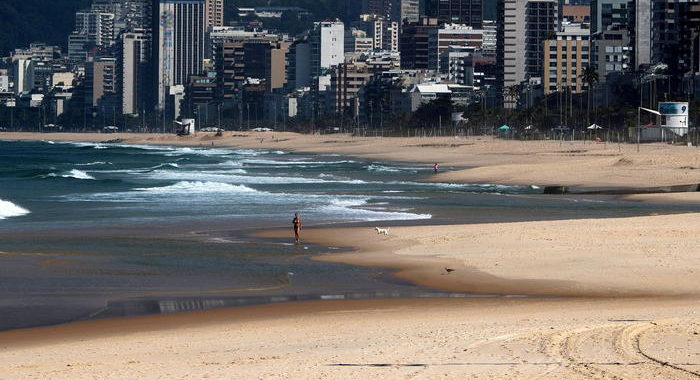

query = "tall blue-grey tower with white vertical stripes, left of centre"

[154,0,206,109]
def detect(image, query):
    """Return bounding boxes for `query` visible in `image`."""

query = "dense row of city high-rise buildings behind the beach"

[0,0,700,137]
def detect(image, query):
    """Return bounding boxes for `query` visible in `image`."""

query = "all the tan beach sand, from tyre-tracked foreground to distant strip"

[0,132,700,379]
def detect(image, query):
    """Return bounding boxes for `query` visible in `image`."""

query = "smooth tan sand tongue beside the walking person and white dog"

[256,213,700,298]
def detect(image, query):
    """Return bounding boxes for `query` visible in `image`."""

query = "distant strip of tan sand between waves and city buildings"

[5,132,700,191]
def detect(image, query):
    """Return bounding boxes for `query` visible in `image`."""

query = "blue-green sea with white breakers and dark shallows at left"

[0,141,700,329]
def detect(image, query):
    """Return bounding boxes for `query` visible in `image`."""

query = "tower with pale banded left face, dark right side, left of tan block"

[496,0,558,88]
